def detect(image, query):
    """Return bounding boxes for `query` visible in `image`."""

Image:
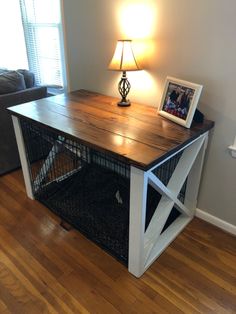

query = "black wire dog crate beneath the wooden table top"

[21,120,187,265]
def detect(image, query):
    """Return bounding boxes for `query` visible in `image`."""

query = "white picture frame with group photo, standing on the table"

[159,76,203,128]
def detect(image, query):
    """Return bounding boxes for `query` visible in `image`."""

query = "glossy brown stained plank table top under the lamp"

[8,90,214,170]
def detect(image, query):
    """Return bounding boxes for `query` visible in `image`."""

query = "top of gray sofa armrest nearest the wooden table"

[0,86,47,108]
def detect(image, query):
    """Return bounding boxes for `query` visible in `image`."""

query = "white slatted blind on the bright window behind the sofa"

[20,0,65,90]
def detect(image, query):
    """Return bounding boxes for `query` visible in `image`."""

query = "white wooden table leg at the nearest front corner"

[128,167,148,277]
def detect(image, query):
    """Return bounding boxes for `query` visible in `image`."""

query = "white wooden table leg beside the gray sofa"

[12,116,34,200]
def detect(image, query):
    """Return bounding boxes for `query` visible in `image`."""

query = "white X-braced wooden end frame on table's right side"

[128,132,208,277]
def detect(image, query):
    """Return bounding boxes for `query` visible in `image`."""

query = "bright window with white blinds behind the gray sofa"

[0,0,66,93]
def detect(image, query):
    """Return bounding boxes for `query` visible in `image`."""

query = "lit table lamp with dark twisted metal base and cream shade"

[108,39,141,107]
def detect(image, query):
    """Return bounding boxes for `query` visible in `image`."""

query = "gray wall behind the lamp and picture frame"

[64,0,236,225]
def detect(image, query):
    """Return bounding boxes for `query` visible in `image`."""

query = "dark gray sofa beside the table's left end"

[0,69,47,175]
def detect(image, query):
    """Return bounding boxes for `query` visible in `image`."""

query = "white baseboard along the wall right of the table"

[195,208,236,235]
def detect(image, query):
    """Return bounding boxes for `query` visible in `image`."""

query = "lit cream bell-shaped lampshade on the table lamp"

[108,40,141,71]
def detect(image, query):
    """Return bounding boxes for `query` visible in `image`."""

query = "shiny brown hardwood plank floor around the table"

[0,171,236,314]
